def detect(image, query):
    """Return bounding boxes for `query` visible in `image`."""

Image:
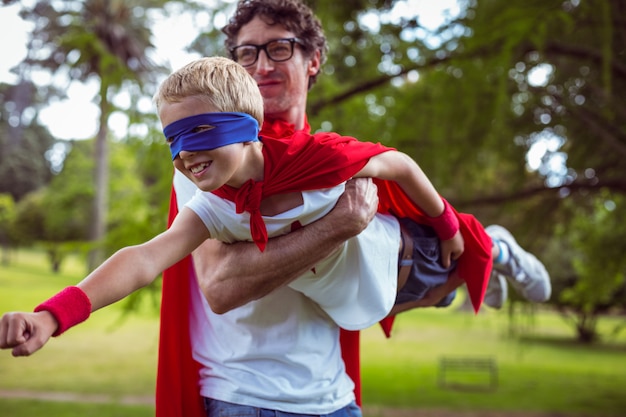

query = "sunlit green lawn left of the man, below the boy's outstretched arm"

[0,251,159,417]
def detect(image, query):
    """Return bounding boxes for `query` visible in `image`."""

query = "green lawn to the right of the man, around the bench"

[361,309,626,417]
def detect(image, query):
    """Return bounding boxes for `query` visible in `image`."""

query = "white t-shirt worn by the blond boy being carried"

[186,175,400,330]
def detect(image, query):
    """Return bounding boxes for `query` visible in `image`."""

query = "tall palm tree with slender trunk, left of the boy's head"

[16,0,164,268]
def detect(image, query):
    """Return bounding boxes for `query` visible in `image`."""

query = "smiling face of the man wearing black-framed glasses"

[237,16,320,128]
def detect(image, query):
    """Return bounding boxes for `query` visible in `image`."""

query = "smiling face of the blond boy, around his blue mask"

[159,97,253,191]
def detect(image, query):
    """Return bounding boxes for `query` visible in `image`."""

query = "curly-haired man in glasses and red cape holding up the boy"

[157,0,544,417]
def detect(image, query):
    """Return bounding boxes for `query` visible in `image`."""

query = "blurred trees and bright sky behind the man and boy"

[0,0,626,384]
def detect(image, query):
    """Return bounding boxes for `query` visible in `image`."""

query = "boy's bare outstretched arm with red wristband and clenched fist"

[0,209,209,356]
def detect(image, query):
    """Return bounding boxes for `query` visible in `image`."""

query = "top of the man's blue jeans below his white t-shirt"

[204,398,363,417]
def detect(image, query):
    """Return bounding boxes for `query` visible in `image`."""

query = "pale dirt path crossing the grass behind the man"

[0,390,584,417]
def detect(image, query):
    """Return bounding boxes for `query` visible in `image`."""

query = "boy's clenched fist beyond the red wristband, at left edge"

[0,311,58,356]
